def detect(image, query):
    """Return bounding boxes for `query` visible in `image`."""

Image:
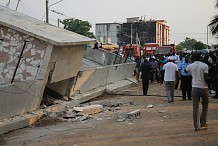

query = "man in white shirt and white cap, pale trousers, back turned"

[163,56,178,103]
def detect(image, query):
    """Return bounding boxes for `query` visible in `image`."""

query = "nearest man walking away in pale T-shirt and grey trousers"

[186,52,209,131]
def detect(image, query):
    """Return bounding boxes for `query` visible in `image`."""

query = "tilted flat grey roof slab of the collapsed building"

[0,6,95,46]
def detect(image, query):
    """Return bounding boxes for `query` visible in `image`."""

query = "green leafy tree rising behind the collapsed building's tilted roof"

[61,18,95,38]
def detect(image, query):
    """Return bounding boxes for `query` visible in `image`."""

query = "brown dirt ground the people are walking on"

[0,83,218,146]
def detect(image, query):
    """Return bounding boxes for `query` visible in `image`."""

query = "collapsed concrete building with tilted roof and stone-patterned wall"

[0,6,135,133]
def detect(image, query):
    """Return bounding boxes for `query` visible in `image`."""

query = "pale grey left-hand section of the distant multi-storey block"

[95,23,121,44]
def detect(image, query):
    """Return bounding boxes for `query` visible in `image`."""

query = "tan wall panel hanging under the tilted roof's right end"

[49,45,85,83]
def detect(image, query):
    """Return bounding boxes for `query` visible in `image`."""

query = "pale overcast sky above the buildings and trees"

[0,0,218,45]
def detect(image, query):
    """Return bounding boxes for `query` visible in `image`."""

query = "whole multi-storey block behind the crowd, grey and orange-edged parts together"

[96,17,170,46]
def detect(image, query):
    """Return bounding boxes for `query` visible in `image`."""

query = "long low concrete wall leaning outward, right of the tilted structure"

[70,62,135,96]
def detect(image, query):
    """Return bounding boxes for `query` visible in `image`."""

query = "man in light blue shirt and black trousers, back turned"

[178,55,192,100]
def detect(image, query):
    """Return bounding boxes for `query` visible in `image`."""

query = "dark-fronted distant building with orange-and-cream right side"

[121,20,170,46]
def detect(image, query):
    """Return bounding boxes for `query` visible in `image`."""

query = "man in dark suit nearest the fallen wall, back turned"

[141,59,151,95]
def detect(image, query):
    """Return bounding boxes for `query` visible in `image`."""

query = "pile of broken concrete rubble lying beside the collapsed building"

[45,100,141,123]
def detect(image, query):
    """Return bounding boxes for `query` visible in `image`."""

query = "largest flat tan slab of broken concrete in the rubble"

[73,105,103,115]
